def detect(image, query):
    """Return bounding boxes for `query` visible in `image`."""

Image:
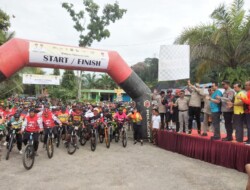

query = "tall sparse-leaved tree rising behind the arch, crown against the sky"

[62,0,126,100]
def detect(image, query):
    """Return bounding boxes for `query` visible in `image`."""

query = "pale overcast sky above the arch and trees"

[0,0,250,70]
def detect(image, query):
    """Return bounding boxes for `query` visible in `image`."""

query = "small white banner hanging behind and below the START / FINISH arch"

[23,74,61,85]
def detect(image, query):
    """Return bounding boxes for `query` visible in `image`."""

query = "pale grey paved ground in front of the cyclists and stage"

[0,137,247,190]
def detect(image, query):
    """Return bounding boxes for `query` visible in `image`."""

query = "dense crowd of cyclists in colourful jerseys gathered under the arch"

[0,97,143,154]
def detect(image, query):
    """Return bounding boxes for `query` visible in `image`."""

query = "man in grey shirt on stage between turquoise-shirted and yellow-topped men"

[217,80,235,141]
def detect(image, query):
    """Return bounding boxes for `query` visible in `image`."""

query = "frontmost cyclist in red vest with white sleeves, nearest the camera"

[21,108,43,156]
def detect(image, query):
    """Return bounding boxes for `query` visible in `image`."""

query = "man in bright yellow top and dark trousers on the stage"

[227,82,246,142]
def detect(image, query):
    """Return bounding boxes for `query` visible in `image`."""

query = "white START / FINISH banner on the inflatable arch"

[29,42,109,69]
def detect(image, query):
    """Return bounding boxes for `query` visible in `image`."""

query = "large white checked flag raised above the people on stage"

[158,45,190,81]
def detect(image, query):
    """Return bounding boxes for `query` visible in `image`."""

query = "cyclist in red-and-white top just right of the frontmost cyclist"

[42,108,62,145]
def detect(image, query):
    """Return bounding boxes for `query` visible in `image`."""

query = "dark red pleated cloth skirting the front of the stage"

[158,130,250,172]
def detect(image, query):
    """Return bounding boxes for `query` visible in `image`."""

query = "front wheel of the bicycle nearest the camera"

[23,145,35,170]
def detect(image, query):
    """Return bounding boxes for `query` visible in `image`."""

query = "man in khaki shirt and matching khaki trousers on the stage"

[174,90,189,133]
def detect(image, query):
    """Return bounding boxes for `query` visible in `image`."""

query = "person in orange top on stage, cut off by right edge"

[241,81,250,145]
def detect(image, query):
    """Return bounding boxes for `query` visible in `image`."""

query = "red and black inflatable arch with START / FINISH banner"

[0,38,151,138]
